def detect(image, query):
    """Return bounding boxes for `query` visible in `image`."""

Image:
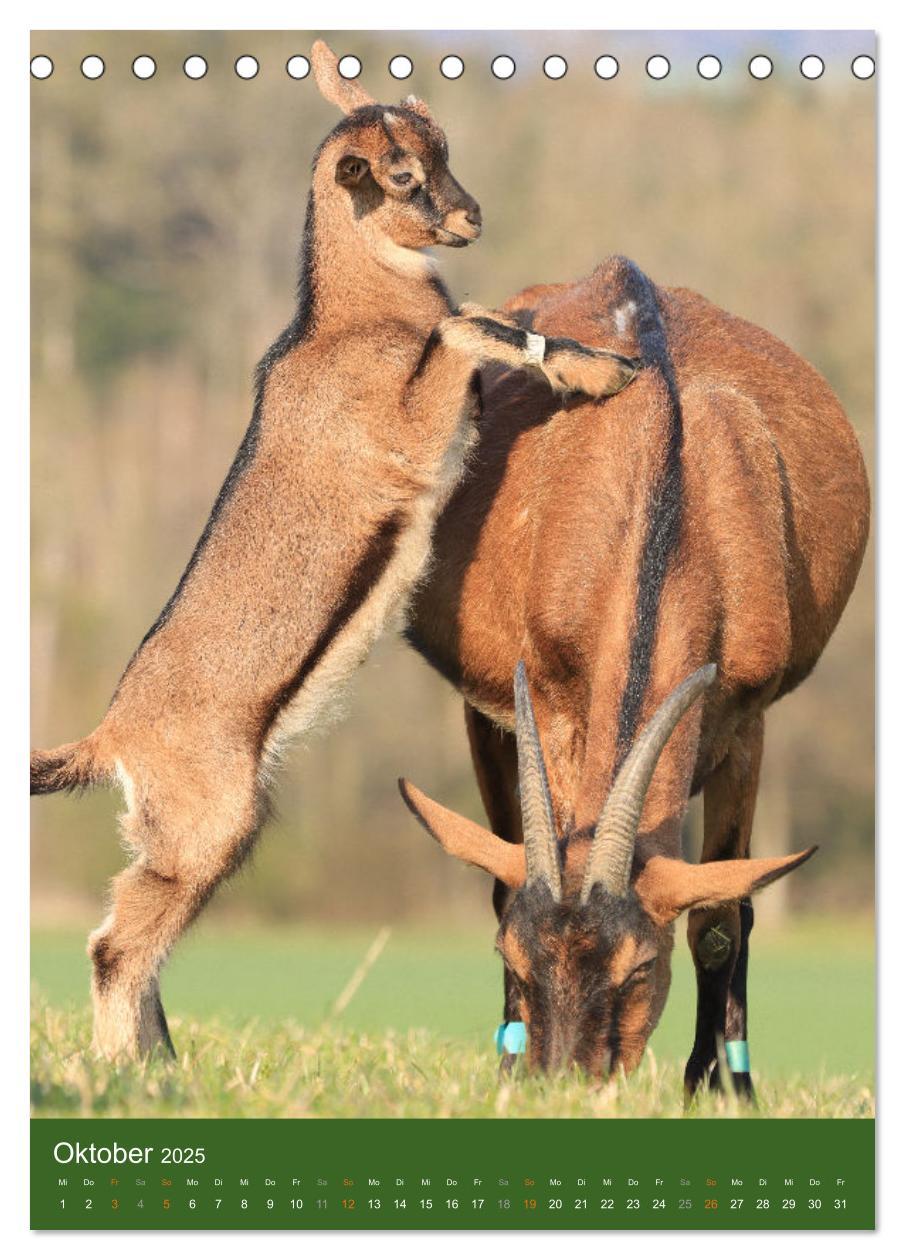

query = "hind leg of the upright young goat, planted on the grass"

[88,756,258,1060]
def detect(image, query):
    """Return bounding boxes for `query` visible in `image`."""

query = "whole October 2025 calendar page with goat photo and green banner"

[30,30,876,1231]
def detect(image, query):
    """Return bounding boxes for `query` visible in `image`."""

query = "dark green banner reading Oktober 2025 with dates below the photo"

[32,1119,873,1230]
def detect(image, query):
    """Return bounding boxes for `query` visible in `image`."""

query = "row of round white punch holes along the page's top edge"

[32,53,876,79]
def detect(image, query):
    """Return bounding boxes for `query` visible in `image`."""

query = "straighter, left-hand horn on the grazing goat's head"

[516,660,562,901]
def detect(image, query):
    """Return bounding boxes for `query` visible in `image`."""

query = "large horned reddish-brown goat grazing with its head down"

[402,258,870,1094]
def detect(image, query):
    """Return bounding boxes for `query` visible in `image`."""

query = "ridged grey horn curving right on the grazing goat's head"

[581,665,716,903]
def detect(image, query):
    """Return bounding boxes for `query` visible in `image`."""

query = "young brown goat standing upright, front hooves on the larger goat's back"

[32,43,637,1057]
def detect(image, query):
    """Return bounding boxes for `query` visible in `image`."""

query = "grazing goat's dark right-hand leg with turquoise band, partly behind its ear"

[684,716,764,1099]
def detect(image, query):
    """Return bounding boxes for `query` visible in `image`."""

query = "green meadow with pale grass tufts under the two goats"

[32,920,873,1116]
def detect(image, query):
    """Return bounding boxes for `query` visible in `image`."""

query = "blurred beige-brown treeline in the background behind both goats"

[32,32,875,922]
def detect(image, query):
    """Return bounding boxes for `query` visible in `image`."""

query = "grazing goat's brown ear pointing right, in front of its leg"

[634,845,817,925]
